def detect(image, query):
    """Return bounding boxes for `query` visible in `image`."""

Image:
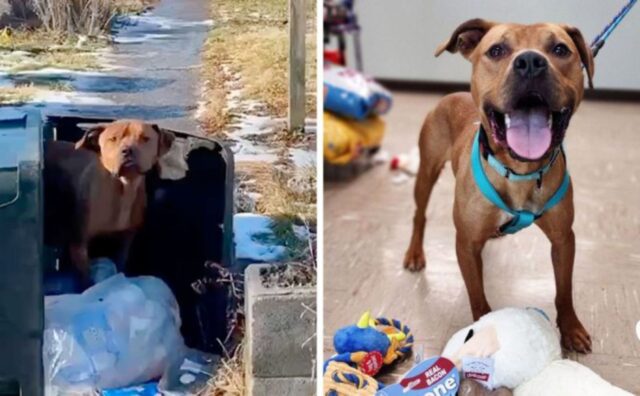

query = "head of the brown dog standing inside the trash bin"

[76,121,175,179]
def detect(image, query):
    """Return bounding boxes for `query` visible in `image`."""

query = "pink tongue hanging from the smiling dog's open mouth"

[507,108,551,160]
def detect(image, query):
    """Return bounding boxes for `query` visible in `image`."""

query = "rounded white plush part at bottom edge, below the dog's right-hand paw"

[513,359,633,396]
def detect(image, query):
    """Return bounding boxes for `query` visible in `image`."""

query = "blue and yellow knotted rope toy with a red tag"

[325,312,413,376]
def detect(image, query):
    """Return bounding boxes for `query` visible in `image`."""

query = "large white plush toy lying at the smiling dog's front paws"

[442,308,633,396]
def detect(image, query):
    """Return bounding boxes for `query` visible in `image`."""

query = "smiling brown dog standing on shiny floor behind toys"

[404,19,594,352]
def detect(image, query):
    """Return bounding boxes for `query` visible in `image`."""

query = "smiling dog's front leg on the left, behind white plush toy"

[456,231,491,321]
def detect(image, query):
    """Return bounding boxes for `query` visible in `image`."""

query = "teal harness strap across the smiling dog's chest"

[471,129,571,235]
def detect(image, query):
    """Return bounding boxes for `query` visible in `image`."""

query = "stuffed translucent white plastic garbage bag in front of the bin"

[43,274,186,394]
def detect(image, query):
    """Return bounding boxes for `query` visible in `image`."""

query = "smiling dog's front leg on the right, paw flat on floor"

[536,189,591,353]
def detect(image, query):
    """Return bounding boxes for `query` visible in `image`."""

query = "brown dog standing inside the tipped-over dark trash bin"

[44,120,175,280]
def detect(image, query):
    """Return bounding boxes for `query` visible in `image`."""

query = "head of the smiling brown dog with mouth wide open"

[436,19,594,161]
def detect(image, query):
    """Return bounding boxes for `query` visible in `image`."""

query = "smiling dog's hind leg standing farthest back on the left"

[404,113,450,271]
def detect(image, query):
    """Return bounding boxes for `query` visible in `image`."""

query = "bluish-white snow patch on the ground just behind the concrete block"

[233,213,286,262]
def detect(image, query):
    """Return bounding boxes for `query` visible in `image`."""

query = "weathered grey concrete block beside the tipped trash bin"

[245,264,316,396]
